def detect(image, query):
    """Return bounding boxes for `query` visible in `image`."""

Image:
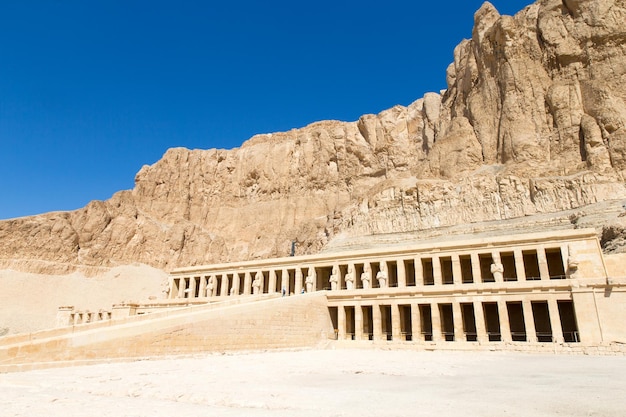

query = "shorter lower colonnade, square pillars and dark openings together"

[330,294,580,343]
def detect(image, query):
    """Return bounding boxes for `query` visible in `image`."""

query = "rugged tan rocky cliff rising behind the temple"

[0,0,626,273]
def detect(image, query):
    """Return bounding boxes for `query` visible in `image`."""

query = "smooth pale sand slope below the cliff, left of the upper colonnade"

[0,264,167,335]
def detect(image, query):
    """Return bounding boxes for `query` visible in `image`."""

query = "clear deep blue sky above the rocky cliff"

[0,0,531,219]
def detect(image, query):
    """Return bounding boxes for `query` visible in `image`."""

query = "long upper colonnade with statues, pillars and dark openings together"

[168,244,577,299]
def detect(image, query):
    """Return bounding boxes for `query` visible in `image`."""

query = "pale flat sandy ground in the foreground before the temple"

[0,350,626,417]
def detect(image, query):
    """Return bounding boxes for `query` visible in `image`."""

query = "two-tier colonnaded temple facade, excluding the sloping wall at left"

[168,229,626,345]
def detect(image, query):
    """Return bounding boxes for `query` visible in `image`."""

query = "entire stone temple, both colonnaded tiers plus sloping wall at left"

[0,229,626,372]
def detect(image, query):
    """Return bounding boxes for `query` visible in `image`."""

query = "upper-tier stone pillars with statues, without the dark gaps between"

[169,245,568,298]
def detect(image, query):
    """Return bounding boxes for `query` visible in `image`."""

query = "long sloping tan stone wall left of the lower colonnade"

[0,293,333,372]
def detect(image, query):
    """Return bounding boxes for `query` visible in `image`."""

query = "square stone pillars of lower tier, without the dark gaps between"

[336,299,564,343]
